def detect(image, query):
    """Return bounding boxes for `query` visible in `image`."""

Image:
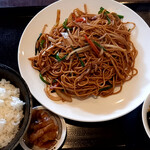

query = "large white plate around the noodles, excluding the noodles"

[18,0,150,122]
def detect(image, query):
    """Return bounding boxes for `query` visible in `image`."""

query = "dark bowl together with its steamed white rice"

[0,64,32,150]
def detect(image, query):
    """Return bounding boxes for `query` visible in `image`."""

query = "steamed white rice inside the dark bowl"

[0,79,24,148]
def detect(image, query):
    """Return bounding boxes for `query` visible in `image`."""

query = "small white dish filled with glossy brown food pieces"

[20,106,66,150]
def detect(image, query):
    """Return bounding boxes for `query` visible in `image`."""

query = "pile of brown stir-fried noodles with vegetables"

[29,5,138,101]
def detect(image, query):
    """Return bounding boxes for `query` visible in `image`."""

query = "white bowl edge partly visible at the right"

[142,93,150,138]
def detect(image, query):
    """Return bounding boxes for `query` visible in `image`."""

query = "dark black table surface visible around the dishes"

[0,0,150,150]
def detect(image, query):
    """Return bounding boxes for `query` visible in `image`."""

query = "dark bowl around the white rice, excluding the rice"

[0,64,32,150]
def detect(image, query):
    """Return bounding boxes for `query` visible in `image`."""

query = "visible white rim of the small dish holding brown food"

[20,106,67,150]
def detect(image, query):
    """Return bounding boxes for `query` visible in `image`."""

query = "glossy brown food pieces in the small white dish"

[27,109,58,149]
